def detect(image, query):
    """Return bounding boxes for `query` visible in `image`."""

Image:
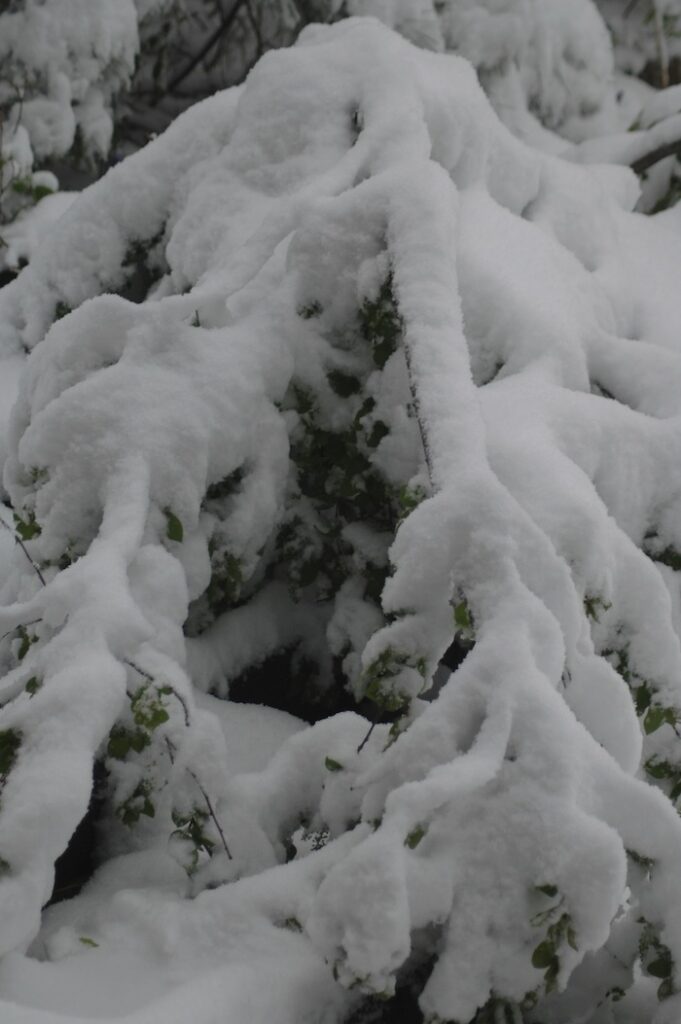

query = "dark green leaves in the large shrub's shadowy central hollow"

[275,275,417,684]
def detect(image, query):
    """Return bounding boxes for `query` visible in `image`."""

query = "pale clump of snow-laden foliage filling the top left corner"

[0,0,143,269]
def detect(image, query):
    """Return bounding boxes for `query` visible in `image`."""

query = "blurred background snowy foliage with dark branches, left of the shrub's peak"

[0,0,284,269]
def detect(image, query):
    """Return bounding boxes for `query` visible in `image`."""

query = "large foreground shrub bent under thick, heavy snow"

[5,19,681,1024]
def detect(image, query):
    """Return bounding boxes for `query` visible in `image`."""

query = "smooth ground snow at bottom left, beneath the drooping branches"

[0,696,331,1024]
